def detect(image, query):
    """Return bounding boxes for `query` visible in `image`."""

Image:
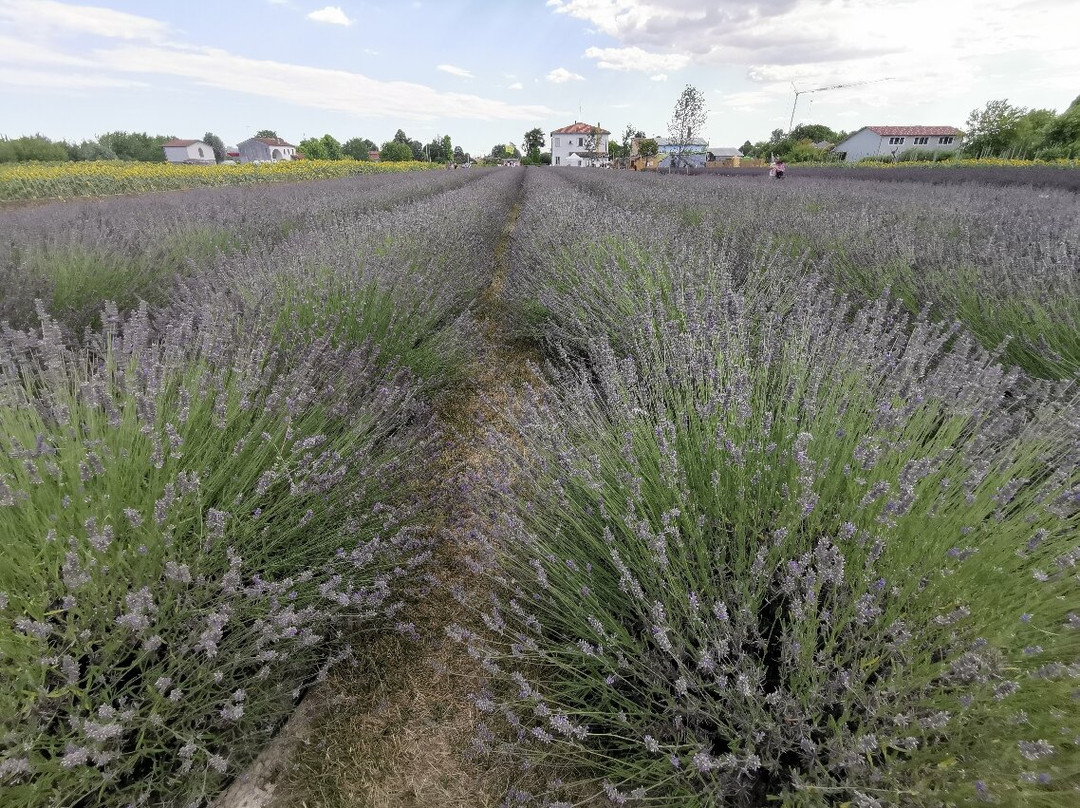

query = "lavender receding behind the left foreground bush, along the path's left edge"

[162,172,517,394]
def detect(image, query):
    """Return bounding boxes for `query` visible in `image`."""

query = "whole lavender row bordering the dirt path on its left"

[0,168,514,806]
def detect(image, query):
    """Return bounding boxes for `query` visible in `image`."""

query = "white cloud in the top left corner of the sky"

[0,0,167,40]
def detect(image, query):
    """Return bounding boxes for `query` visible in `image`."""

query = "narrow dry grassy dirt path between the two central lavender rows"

[215,170,534,808]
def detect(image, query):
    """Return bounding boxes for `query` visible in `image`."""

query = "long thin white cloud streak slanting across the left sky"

[94,45,556,121]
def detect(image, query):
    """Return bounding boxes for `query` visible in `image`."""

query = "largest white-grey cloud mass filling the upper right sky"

[548,0,1080,104]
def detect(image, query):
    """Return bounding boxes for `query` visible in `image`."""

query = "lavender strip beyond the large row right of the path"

[548,172,1080,378]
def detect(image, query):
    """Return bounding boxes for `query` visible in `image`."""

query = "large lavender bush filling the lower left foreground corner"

[0,300,438,805]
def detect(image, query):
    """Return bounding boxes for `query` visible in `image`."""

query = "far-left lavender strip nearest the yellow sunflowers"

[0,172,490,338]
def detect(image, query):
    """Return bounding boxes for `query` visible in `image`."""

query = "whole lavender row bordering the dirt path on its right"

[450,167,1080,808]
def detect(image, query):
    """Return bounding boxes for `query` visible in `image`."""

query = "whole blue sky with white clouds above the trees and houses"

[0,0,1080,154]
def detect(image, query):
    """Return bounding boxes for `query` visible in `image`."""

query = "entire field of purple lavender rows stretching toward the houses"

[0,169,1080,808]
